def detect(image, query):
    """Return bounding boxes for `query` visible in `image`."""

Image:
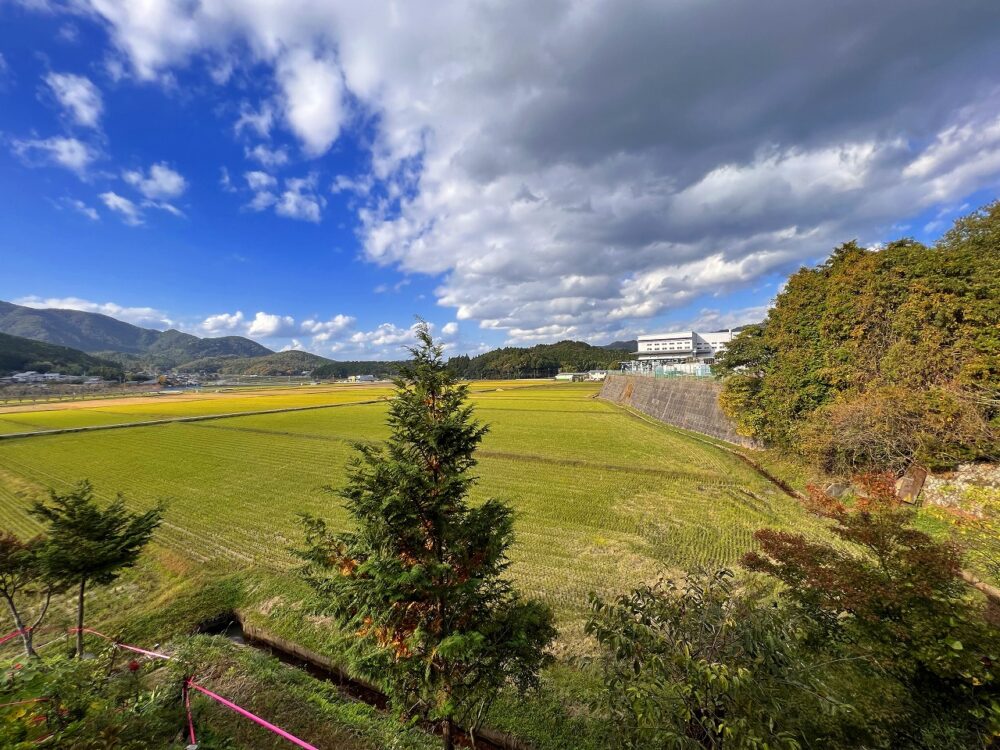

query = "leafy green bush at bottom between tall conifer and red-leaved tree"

[586,569,841,750]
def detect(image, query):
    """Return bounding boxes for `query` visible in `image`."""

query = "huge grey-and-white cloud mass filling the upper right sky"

[47,0,1000,340]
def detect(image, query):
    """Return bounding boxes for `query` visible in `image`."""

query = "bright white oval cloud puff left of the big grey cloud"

[277,48,345,156]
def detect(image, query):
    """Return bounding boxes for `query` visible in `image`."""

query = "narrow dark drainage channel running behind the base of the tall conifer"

[198,612,532,750]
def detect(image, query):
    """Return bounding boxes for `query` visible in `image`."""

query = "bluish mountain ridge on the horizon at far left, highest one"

[0,302,273,367]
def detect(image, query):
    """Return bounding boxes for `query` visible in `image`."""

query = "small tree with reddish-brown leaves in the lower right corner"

[743,475,1000,744]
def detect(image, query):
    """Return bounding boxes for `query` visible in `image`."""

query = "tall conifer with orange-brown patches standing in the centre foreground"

[302,323,555,748]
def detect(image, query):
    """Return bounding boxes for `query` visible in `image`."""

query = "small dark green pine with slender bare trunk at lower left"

[31,480,163,657]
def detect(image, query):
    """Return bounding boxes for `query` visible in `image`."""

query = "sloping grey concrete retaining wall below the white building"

[600,375,755,448]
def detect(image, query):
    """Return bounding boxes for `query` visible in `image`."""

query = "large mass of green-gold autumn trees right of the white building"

[715,202,1000,475]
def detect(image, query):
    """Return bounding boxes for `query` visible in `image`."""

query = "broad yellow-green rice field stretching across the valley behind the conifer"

[0,382,832,620]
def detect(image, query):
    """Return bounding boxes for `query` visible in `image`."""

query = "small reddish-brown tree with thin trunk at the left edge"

[0,532,53,657]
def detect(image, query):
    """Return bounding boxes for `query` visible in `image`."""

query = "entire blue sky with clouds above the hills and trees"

[0,0,1000,359]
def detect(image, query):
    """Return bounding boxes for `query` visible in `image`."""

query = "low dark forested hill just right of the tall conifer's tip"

[448,341,633,378]
